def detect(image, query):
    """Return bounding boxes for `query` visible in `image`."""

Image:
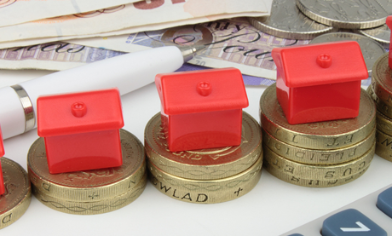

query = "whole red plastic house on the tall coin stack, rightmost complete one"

[272,41,368,124]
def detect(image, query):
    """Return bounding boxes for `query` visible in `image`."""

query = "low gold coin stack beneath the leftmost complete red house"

[27,129,147,215]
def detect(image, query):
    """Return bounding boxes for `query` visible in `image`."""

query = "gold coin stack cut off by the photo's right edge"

[367,53,392,161]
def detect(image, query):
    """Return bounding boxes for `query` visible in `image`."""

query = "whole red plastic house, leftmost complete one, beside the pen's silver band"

[37,89,124,174]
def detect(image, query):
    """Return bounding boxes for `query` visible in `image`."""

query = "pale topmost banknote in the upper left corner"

[0,0,141,27]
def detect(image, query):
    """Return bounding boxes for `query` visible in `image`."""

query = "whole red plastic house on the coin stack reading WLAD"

[155,68,249,151]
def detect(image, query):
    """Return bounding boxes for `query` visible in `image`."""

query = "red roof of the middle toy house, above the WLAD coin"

[155,68,249,115]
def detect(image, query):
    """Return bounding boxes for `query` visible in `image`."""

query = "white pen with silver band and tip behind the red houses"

[0,46,202,139]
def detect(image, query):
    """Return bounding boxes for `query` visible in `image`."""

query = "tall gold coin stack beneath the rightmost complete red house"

[260,85,376,187]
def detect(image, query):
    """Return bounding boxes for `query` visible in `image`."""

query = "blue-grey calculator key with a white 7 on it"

[321,209,387,236]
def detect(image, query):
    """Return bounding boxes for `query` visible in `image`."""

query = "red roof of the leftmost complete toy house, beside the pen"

[37,89,124,137]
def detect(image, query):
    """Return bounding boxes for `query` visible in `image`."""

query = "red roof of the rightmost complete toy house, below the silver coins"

[272,41,369,88]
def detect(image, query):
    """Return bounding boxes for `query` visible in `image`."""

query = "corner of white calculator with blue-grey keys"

[282,184,392,236]
